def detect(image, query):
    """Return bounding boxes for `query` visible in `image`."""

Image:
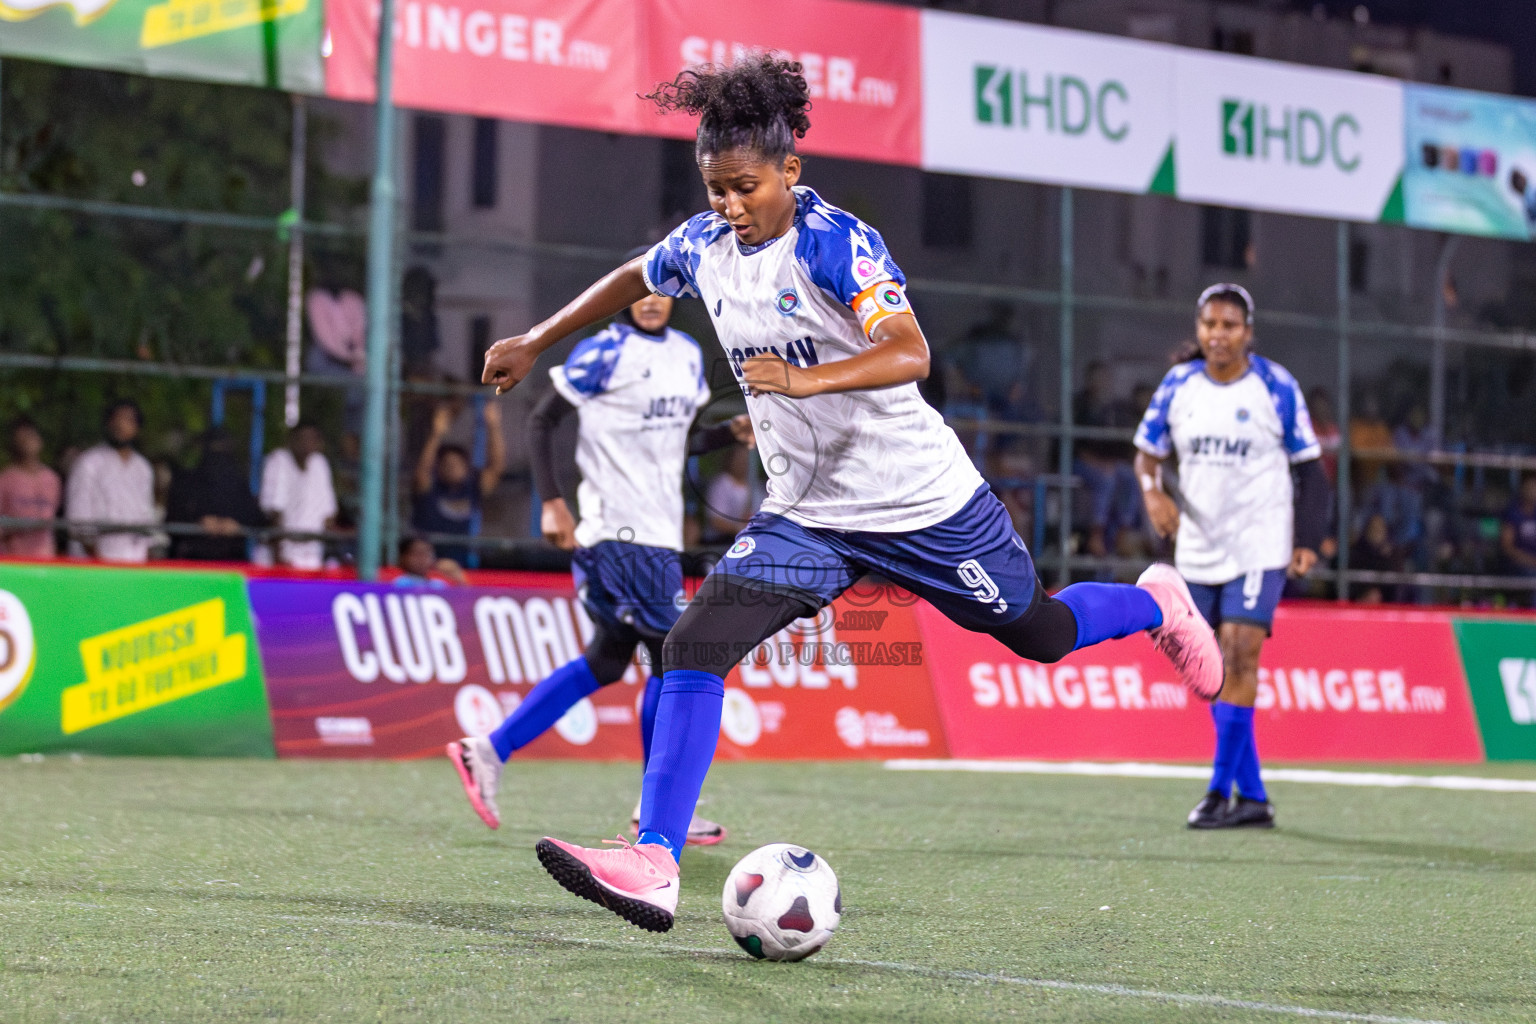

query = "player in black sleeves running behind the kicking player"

[449,267,753,846]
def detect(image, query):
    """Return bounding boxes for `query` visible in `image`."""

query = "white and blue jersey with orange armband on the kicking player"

[645,186,982,533]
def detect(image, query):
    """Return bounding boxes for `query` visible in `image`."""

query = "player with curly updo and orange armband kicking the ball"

[484,55,1221,932]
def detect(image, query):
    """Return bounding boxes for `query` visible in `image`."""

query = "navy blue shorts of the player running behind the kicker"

[571,540,688,640]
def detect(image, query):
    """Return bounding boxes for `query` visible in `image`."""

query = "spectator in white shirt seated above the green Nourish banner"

[65,399,155,562]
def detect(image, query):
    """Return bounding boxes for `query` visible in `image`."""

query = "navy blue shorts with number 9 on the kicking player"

[714,485,1035,633]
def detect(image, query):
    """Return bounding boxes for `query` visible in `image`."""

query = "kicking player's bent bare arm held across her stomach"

[742,313,928,398]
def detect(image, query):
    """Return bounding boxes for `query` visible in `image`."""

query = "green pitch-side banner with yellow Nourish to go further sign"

[0,565,273,757]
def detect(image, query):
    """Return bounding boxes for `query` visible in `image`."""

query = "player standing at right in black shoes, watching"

[1137,284,1330,829]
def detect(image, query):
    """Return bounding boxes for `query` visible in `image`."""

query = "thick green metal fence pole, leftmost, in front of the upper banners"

[358,0,396,580]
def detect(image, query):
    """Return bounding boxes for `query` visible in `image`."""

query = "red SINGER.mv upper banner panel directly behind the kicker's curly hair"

[631,0,923,166]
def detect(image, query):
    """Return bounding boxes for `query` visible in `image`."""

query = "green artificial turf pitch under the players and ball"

[0,757,1536,1024]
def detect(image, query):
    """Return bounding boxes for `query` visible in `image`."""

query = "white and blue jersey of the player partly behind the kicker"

[550,324,710,551]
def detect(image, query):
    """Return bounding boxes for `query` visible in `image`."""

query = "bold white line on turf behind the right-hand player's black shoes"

[885,758,1536,792]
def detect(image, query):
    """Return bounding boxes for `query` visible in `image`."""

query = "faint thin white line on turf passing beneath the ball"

[0,895,1448,1024]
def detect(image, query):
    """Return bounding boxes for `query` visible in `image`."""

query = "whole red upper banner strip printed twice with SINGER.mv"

[326,0,922,166]
